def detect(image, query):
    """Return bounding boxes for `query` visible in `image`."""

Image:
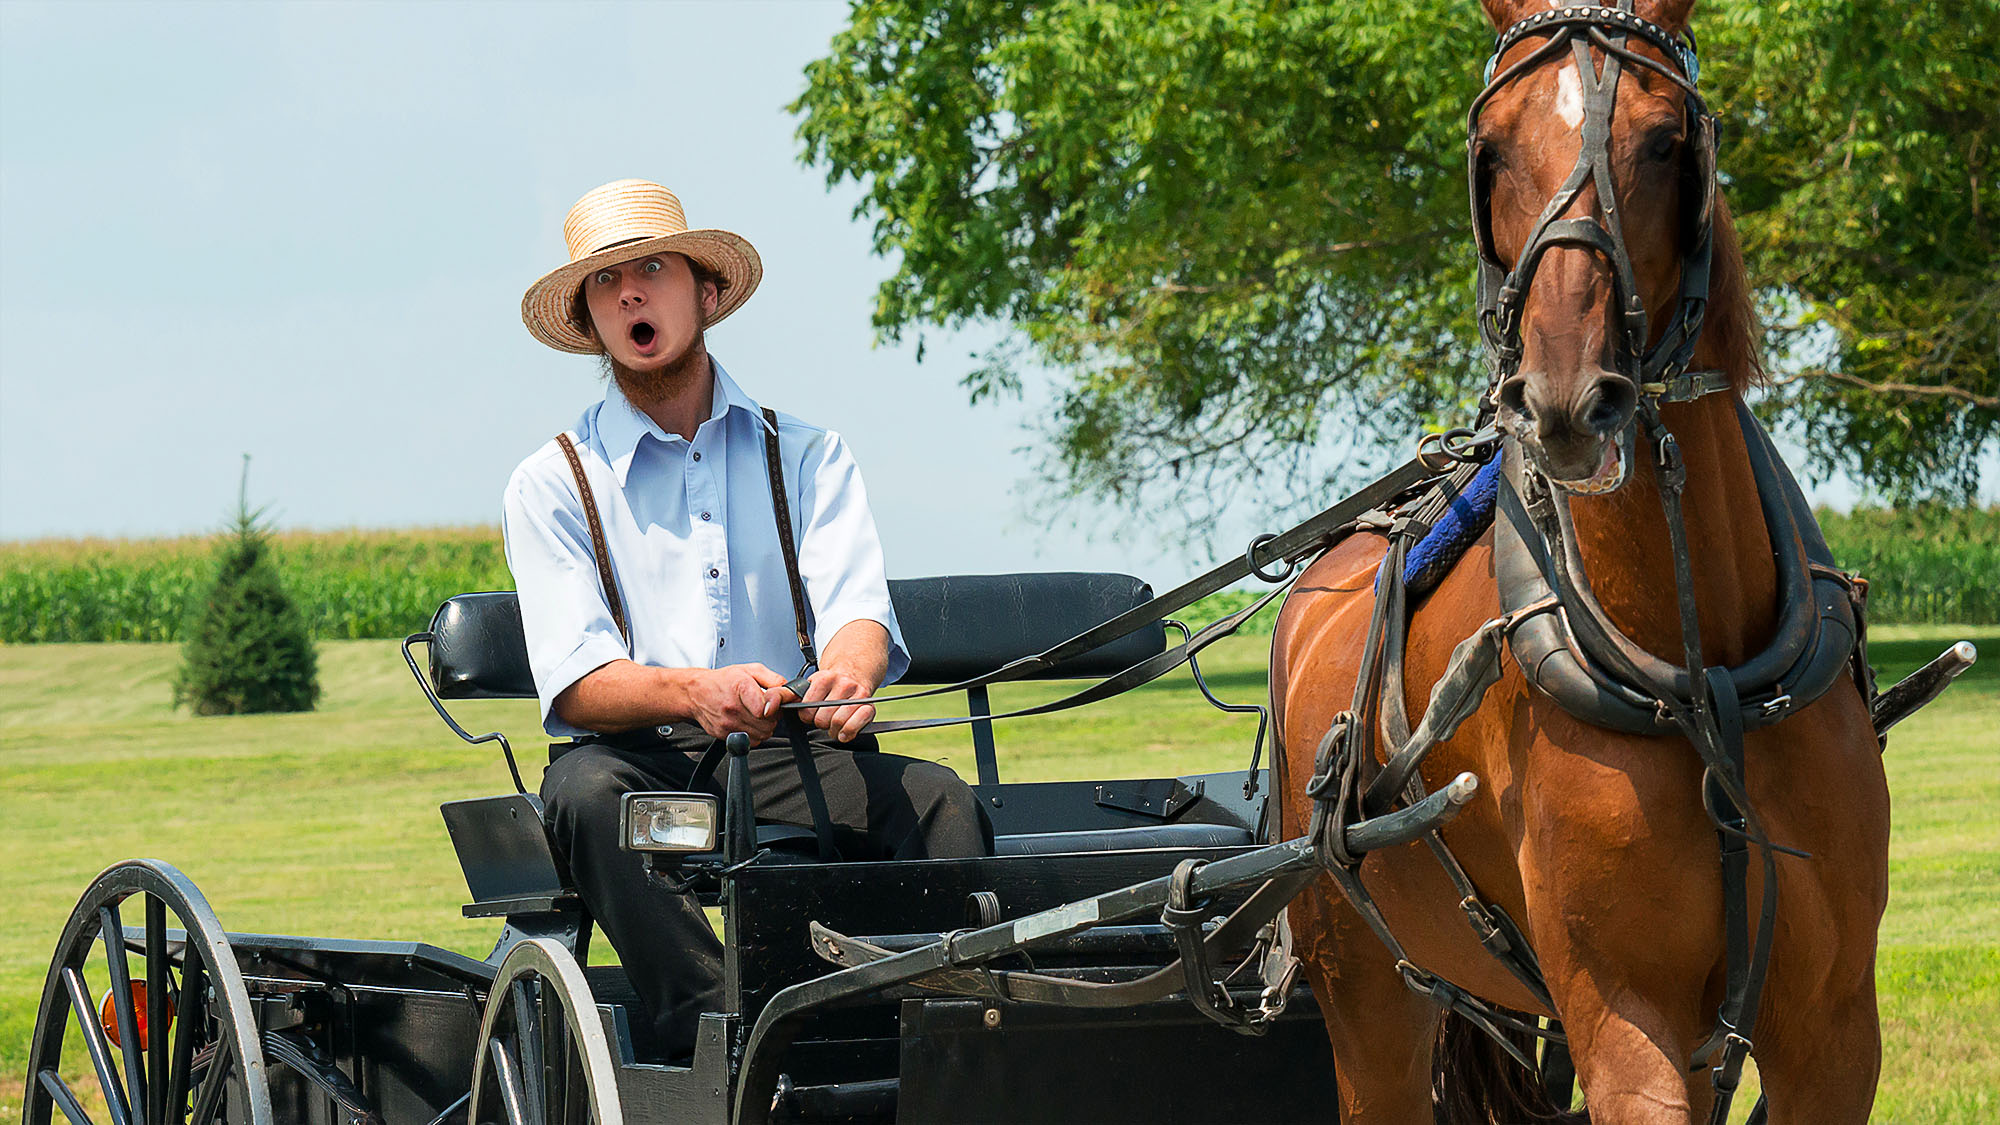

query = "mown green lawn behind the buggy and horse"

[0,627,2000,1123]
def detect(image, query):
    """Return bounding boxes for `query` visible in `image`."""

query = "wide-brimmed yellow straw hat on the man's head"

[520,180,764,354]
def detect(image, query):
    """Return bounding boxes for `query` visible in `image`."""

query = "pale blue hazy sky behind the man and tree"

[0,0,1984,585]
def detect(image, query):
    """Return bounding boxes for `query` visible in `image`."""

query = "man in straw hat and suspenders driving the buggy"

[504,180,992,1059]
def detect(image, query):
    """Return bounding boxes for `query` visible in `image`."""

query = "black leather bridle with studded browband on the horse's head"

[1466,0,1718,402]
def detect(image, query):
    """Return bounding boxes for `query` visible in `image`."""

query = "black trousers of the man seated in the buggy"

[542,725,994,1057]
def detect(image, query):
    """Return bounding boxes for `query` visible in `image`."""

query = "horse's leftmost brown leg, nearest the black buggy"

[1292,883,1438,1125]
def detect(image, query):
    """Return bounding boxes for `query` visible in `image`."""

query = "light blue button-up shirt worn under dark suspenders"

[502,354,910,737]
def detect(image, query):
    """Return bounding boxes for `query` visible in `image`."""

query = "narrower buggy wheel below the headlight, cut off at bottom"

[468,937,624,1125]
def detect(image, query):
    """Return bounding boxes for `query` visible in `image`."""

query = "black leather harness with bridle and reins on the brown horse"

[794,8,1896,1125]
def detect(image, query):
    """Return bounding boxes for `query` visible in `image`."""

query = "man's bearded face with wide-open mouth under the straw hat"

[584,254,716,372]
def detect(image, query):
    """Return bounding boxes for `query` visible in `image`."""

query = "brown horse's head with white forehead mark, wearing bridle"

[1468,0,1714,492]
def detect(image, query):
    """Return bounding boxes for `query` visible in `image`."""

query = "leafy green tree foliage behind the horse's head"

[792,0,2000,516]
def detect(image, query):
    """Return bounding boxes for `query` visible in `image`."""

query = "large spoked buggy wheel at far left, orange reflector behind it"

[22,859,272,1125]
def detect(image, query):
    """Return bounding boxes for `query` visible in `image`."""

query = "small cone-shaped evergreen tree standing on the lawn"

[174,454,320,715]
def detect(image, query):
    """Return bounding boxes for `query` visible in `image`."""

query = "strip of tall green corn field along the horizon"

[0,506,2000,645]
